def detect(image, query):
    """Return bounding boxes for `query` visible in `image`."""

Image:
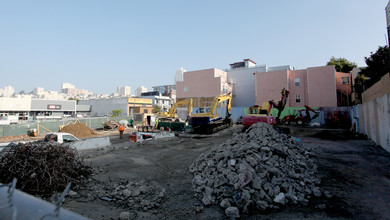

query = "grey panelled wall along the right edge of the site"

[355,93,390,152]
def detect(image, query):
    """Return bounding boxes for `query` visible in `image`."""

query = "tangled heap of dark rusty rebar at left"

[0,142,92,197]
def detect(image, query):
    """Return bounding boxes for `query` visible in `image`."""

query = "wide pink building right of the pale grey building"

[254,66,351,107]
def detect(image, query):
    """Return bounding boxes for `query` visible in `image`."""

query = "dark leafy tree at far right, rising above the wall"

[359,46,390,88]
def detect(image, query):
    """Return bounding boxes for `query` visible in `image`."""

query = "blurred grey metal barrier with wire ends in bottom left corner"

[0,179,88,220]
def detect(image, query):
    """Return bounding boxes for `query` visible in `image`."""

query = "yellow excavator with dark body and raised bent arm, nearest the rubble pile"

[188,93,233,134]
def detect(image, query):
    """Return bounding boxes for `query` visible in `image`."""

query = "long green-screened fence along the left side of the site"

[0,116,132,137]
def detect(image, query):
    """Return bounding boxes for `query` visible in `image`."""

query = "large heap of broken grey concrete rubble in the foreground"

[190,123,323,217]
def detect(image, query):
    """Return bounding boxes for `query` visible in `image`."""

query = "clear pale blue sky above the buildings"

[0,0,388,94]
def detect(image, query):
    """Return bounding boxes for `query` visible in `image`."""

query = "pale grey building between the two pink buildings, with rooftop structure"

[226,59,293,107]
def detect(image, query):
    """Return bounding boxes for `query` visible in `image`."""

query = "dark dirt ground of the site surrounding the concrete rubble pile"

[63,128,390,219]
